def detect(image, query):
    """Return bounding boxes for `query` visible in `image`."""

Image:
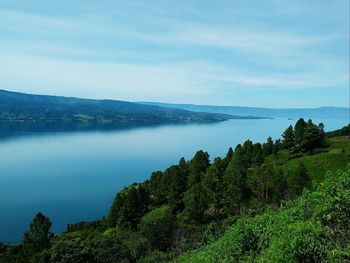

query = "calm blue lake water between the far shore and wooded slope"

[0,119,348,243]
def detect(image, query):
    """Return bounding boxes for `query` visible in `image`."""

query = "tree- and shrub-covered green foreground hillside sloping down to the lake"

[0,119,350,262]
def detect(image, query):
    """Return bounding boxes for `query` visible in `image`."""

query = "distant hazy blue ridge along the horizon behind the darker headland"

[141,102,350,119]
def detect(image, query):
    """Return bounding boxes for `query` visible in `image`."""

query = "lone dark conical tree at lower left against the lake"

[22,212,53,254]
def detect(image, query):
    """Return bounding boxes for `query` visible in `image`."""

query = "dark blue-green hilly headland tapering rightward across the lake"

[0,90,244,126]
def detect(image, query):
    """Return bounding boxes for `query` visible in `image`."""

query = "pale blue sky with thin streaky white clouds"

[0,0,350,108]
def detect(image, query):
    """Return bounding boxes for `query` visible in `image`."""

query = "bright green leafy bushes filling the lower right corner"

[177,168,350,263]
